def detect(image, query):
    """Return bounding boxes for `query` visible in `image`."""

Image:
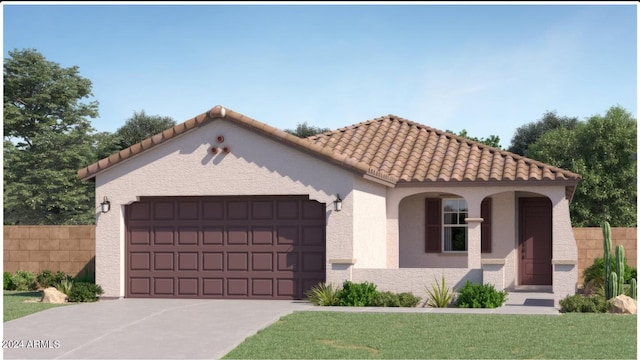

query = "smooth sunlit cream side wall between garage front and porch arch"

[353,178,387,268]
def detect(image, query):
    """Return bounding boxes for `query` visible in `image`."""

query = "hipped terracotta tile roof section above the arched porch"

[306,115,581,183]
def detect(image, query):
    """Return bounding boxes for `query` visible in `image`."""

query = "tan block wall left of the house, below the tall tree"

[3,225,96,276]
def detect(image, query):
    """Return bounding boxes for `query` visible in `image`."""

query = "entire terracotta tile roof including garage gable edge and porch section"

[78,106,581,193]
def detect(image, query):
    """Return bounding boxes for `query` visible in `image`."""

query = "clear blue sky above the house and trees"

[2,2,638,147]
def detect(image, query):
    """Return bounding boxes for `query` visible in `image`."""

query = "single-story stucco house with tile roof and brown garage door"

[78,106,580,306]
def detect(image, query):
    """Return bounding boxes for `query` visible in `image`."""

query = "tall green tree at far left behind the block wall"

[3,49,98,224]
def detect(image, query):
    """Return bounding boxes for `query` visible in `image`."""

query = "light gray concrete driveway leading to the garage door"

[3,299,313,359]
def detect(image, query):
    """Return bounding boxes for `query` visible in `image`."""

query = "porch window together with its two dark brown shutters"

[425,198,492,253]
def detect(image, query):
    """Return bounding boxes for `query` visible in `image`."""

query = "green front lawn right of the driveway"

[224,312,637,359]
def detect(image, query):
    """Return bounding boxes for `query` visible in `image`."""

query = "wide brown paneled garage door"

[125,196,326,299]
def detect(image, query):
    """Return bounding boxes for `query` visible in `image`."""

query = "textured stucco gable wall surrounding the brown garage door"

[96,120,357,297]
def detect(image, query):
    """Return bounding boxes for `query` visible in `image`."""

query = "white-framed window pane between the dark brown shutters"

[442,199,468,252]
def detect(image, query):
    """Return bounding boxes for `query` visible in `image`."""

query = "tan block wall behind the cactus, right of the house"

[573,227,638,286]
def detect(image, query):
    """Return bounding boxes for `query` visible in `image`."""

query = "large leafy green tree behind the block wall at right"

[528,106,637,227]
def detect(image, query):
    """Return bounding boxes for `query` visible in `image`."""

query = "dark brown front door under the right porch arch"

[518,198,552,285]
